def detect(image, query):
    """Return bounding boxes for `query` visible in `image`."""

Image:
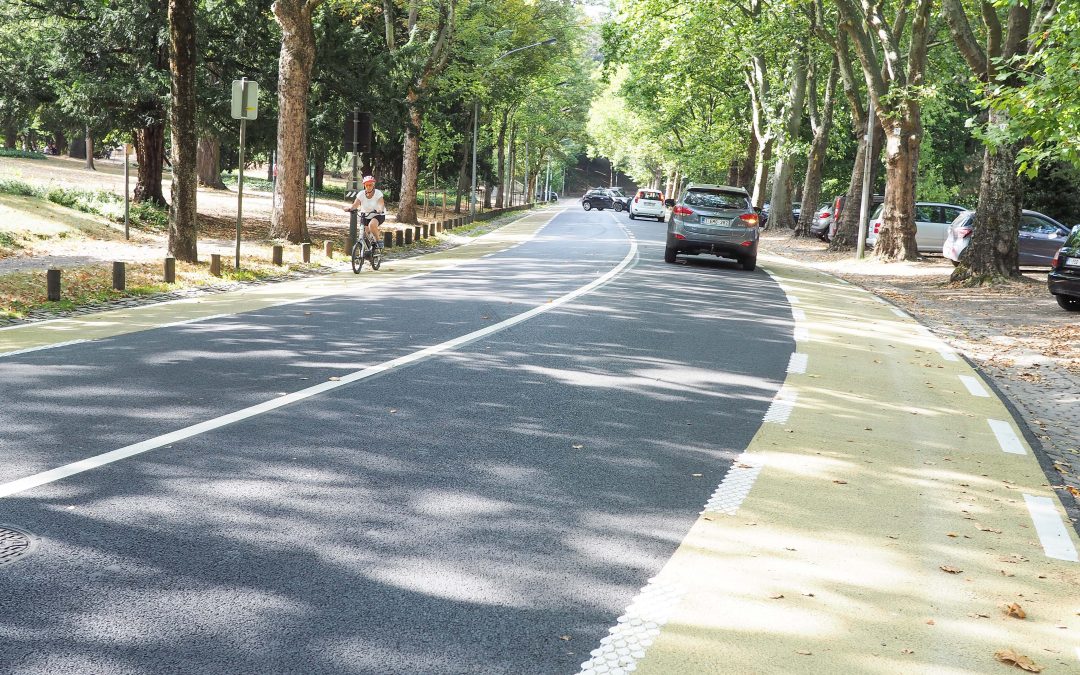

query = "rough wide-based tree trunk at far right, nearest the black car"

[951,107,1024,285]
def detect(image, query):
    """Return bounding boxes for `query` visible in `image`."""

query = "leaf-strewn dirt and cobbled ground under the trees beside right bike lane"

[762,232,1080,504]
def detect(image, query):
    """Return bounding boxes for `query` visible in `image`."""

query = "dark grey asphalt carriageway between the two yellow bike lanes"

[0,208,794,673]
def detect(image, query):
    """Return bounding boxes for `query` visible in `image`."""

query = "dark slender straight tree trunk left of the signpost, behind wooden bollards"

[168,0,199,262]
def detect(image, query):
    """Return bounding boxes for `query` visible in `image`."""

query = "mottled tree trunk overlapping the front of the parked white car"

[874,119,922,260]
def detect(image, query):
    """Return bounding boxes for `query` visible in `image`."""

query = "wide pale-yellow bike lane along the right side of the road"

[581,256,1080,674]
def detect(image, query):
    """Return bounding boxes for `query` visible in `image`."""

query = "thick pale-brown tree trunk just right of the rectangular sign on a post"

[270,0,318,244]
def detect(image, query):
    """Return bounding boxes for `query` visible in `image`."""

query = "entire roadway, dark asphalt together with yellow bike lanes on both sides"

[0,206,1080,673]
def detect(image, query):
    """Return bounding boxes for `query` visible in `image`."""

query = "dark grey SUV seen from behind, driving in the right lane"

[664,184,759,271]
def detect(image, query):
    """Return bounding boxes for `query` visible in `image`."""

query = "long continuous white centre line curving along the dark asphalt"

[0,240,637,499]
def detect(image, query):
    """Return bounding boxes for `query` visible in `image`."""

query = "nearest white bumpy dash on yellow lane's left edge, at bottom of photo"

[579,576,686,675]
